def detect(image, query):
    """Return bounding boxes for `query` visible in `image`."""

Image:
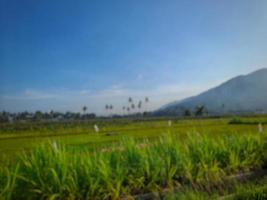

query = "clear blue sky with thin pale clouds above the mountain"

[0,0,267,114]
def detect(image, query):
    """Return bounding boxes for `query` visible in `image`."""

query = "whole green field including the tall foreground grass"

[0,116,267,199]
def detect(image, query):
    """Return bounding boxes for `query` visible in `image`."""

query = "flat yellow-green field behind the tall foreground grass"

[0,116,267,159]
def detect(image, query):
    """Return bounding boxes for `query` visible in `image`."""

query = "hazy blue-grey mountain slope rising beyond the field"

[154,68,267,115]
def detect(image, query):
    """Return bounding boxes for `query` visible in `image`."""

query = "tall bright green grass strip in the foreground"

[0,130,267,199]
